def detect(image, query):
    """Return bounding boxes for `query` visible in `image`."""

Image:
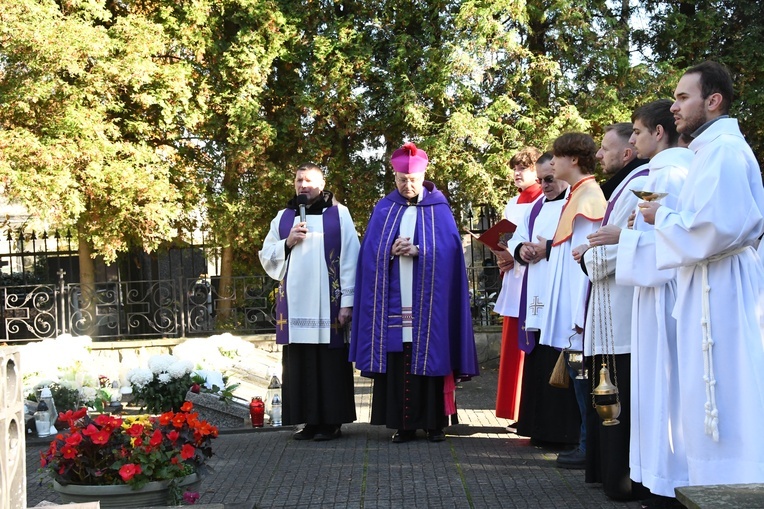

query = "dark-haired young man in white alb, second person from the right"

[591,99,693,502]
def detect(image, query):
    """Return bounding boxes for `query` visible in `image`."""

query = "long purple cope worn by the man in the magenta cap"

[350,181,479,378]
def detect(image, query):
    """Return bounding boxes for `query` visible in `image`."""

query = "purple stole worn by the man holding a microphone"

[276,205,345,348]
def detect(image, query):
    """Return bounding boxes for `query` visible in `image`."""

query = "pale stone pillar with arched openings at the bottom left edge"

[0,347,27,509]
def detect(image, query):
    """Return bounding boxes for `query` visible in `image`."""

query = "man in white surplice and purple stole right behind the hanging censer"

[581,122,647,500]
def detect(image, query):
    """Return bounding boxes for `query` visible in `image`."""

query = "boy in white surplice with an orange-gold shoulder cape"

[536,133,607,469]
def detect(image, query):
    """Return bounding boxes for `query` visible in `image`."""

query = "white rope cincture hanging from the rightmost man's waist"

[698,246,749,442]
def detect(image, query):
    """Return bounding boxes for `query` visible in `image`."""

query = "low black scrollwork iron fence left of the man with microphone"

[0,276,276,342]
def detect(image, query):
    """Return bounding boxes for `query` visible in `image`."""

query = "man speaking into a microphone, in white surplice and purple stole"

[260,163,360,441]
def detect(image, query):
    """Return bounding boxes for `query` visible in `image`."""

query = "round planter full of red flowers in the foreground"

[41,402,218,508]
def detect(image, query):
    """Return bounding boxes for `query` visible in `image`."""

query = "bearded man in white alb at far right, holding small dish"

[640,62,764,485]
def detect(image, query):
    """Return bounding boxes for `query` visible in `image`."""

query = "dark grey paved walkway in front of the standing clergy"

[27,370,639,509]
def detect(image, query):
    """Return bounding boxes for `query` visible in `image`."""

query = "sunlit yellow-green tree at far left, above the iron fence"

[0,0,193,298]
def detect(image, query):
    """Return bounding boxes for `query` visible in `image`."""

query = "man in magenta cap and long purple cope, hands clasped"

[350,143,478,443]
